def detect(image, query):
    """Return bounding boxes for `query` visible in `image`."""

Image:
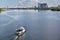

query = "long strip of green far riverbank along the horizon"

[0,7,60,12]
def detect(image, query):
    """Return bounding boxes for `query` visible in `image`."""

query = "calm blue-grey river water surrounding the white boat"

[0,10,60,40]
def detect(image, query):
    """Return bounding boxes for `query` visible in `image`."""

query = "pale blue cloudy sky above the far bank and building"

[0,0,60,7]
